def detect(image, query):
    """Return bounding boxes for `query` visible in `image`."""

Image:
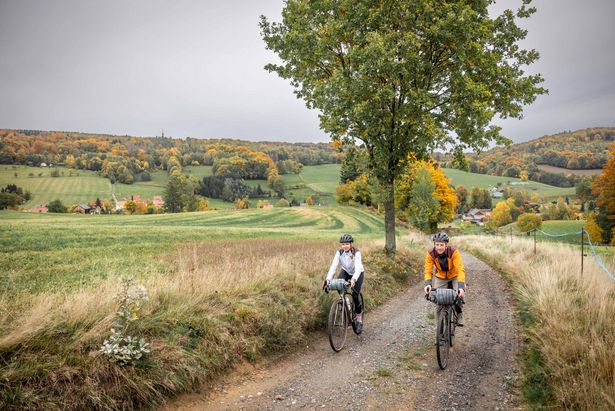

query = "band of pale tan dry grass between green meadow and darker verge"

[0,240,335,350]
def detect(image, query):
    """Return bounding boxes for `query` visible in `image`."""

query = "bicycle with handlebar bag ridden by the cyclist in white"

[325,278,365,352]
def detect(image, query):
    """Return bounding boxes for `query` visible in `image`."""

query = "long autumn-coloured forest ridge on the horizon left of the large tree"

[0,130,344,184]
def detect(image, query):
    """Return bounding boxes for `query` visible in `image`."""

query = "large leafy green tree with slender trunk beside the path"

[260,0,545,252]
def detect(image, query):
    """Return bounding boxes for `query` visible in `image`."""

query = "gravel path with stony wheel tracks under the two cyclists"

[165,253,518,410]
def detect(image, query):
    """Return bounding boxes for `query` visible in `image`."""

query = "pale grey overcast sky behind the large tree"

[0,0,615,142]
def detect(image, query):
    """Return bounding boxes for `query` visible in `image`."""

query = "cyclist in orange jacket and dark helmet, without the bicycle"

[425,232,466,327]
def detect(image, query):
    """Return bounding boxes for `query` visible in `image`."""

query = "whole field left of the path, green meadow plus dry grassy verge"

[0,206,424,409]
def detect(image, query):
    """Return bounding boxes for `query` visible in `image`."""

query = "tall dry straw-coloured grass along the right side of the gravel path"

[455,236,615,409]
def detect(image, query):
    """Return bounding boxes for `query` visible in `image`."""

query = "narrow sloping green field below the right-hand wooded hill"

[443,168,575,199]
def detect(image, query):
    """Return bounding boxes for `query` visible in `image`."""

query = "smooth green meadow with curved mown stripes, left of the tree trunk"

[0,206,384,297]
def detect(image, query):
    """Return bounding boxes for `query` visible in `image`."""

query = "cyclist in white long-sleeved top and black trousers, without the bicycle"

[322,234,365,334]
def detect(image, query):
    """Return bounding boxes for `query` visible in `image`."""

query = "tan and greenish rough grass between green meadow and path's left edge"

[0,239,418,409]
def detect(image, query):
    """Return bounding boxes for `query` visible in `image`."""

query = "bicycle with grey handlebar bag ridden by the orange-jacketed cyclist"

[425,288,463,370]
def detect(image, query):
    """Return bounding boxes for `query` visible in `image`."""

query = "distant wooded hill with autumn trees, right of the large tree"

[444,127,615,187]
